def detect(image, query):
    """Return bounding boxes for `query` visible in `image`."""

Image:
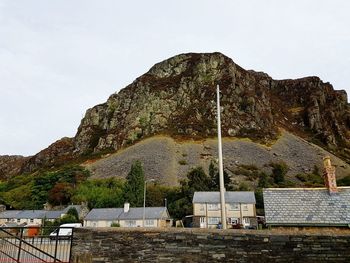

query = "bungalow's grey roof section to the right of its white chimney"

[118,207,169,220]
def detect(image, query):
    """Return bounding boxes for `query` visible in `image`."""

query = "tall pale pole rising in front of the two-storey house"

[216,85,227,229]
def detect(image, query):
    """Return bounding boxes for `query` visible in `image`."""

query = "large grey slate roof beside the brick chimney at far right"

[263,187,350,225]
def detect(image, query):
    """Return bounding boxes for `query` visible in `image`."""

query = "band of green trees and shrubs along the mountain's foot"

[0,161,350,223]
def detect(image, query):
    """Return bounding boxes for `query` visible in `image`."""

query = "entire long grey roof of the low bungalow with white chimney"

[85,207,169,221]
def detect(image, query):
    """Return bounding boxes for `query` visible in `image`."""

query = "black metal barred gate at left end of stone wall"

[0,227,74,263]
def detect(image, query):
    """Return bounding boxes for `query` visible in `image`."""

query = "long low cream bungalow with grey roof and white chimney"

[84,203,172,227]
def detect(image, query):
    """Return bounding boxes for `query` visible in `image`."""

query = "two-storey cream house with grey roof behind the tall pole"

[192,191,257,228]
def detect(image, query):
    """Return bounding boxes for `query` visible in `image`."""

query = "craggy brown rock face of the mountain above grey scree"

[1,53,350,183]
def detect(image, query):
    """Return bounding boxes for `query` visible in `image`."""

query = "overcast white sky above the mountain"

[0,0,350,155]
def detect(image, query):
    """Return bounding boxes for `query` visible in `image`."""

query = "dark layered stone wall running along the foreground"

[72,228,350,263]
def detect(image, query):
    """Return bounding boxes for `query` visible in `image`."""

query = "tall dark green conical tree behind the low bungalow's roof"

[124,161,145,207]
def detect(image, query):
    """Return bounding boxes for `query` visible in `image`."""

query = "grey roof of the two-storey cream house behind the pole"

[192,191,255,204]
